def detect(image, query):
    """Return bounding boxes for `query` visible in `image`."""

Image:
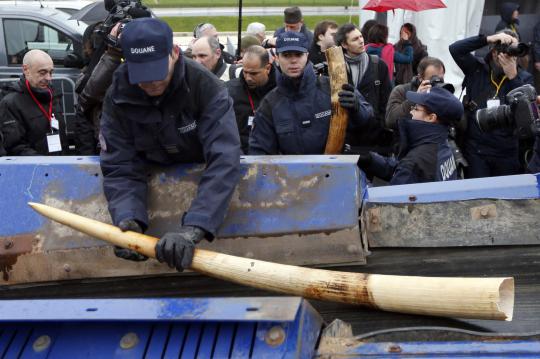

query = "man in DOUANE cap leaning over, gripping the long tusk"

[100,18,240,271]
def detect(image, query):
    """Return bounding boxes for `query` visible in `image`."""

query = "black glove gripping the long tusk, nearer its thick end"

[156,226,205,272]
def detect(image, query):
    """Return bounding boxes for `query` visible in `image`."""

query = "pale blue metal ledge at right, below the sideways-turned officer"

[364,174,540,203]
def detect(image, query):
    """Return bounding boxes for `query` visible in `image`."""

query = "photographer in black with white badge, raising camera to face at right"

[449,30,533,178]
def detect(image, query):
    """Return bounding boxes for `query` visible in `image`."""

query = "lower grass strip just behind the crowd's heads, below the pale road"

[162,16,358,32]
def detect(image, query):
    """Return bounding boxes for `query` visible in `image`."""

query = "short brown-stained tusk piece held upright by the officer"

[324,46,349,155]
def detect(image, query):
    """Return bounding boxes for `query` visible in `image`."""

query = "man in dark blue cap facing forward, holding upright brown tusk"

[249,31,373,155]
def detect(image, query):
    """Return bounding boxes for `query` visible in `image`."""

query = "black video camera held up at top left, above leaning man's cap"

[96,0,152,48]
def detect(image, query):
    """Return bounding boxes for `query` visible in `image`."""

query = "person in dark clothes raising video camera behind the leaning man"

[75,0,151,155]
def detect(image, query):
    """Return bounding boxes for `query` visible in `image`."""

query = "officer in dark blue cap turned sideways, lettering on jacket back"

[358,87,463,185]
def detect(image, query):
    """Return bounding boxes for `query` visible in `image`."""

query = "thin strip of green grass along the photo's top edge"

[148,0,352,8]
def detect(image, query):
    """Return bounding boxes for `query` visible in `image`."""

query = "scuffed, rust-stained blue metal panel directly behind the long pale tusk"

[0,156,363,238]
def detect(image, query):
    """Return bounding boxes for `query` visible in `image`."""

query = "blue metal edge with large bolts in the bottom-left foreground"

[0,297,322,358]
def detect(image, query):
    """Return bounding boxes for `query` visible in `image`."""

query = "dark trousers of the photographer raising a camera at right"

[465,153,521,178]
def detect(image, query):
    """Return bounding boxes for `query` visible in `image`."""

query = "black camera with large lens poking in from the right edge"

[476,85,540,138]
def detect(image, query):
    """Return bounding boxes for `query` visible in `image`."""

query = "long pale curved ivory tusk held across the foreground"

[29,203,514,320]
